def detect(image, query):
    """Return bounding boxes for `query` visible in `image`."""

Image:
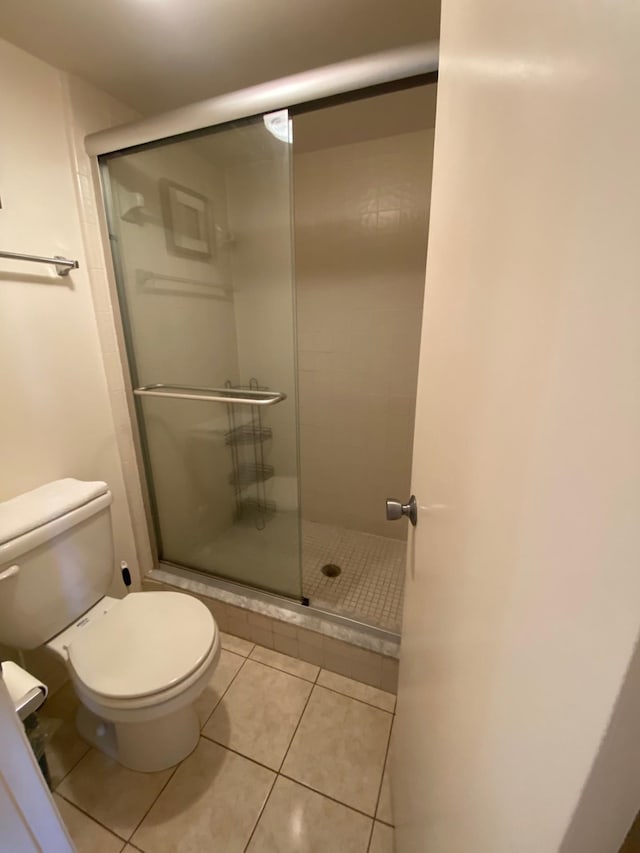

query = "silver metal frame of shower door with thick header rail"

[91,42,438,643]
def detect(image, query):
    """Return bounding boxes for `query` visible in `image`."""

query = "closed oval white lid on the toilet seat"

[67,592,216,699]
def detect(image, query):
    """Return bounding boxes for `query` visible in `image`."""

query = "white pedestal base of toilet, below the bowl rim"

[76,703,200,773]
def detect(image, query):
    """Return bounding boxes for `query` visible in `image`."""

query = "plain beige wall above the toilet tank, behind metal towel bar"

[0,41,144,686]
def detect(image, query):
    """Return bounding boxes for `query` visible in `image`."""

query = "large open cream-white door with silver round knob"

[393,0,640,853]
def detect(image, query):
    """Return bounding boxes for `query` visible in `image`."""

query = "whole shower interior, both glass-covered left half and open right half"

[99,46,435,633]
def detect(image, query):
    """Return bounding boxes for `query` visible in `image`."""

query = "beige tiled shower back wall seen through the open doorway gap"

[294,129,433,538]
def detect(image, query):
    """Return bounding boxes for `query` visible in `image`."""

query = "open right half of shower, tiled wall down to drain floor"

[293,85,435,632]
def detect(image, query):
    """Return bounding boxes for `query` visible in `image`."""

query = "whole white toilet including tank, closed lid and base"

[0,478,220,772]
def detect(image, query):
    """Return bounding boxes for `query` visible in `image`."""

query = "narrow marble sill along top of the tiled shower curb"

[152,561,400,658]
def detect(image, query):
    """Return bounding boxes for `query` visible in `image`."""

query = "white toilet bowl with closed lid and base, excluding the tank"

[46,592,220,772]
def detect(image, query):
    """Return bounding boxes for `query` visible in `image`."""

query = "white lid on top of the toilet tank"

[0,477,109,545]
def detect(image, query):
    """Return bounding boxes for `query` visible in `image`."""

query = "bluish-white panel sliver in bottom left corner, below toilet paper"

[0,674,75,853]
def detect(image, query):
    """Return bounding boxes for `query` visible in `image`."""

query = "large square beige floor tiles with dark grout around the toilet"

[43,634,395,853]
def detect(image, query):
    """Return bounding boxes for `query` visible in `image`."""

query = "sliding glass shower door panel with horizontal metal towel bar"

[101,111,302,599]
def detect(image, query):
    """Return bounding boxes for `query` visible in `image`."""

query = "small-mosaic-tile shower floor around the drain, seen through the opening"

[302,521,406,633]
